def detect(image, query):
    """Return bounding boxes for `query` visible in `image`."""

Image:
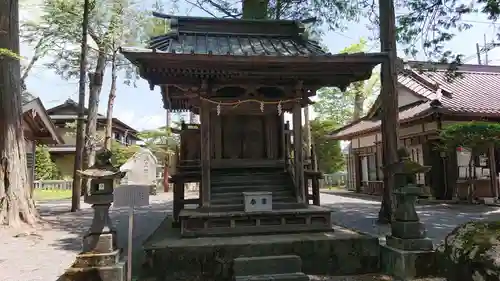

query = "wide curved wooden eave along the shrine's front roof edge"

[122,49,387,87]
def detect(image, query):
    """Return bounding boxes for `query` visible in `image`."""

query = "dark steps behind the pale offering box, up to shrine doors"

[210,168,296,210]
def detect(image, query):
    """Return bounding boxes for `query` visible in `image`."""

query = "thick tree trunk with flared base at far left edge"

[0,0,38,227]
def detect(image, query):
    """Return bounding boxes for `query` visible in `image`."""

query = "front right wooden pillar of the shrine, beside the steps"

[293,103,307,203]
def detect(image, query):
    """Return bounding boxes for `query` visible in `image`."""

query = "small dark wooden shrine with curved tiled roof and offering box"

[121,14,387,237]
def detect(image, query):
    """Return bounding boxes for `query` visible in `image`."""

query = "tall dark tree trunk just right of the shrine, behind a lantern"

[378,0,399,223]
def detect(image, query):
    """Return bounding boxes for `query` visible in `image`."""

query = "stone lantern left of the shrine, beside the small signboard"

[62,150,125,281]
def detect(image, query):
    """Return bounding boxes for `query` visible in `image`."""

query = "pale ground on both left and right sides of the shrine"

[0,193,500,281]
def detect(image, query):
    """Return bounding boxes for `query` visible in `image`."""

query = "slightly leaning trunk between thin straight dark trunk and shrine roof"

[82,48,106,191]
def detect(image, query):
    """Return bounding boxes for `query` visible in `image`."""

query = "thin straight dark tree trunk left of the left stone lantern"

[71,0,90,212]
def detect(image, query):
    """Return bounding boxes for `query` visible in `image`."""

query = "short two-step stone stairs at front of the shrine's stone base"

[233,255,310,281]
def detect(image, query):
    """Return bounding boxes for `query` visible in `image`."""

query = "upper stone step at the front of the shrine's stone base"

[233,255,302,276]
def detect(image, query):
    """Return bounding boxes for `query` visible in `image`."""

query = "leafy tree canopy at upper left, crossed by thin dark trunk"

[21,0,165,85]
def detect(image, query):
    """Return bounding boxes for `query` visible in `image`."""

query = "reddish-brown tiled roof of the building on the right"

[330,62,500,139]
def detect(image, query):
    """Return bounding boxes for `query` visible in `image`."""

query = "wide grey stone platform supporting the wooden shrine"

[144,217,380,281]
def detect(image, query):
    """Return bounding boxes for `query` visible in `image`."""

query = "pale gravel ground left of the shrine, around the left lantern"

[0,190,186,281]
